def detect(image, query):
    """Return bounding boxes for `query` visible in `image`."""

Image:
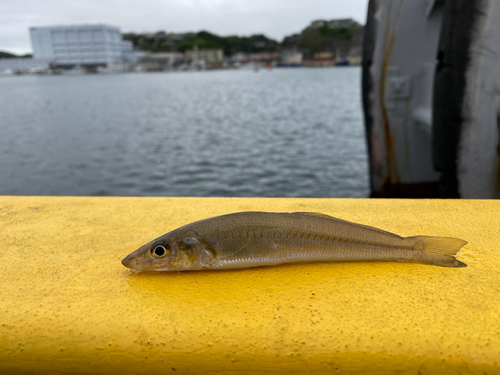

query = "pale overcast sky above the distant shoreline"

[0,0,368,53]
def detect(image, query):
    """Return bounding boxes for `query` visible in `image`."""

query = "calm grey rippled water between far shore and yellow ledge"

[0,68,369,197]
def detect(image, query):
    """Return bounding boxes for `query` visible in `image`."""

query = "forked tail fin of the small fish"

[408,236,467,267]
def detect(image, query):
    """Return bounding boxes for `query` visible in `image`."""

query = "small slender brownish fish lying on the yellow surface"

[122,212,467,271]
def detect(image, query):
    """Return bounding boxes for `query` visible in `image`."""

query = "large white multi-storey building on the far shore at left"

[30,25,126,67]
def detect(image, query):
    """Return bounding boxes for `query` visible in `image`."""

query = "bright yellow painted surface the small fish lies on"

[0,197,500,374]
